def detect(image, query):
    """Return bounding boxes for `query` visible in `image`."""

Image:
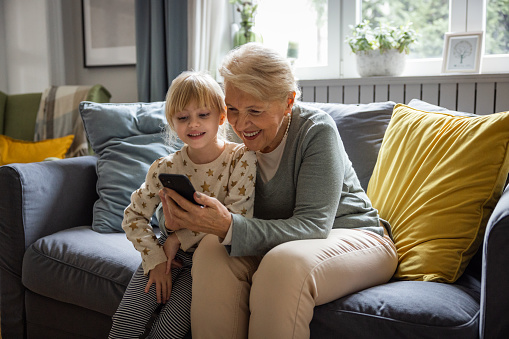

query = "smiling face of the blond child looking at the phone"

[172,101,226,163]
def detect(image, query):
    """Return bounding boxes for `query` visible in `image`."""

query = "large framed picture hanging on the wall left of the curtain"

[81,0,136,67]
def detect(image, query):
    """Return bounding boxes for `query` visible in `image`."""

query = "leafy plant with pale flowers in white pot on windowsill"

[346,20,417,77]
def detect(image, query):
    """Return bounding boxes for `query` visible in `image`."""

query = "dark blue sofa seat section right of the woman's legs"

[311,281,480,339]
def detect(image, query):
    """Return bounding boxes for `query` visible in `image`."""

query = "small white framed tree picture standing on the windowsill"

[442,32,483,73]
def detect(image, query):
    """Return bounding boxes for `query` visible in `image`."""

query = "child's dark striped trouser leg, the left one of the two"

[109,265,159,339]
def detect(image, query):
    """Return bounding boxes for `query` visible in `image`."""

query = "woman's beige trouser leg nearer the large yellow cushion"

[249,229,398,339]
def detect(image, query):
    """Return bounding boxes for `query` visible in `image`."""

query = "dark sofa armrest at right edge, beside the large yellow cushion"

[479,186,509,338]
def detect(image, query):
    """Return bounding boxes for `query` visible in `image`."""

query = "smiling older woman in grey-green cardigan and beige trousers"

[160,43,397,338]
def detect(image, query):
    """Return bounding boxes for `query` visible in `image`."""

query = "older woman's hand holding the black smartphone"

[159,188,232,238]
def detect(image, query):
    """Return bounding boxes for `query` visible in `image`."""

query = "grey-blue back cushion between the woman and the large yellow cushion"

[303,101,396,190]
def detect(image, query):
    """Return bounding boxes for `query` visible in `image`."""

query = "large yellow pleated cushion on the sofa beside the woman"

[367,104,509,282]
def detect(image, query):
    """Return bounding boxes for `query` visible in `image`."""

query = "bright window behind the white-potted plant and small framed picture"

[341,0,509,78]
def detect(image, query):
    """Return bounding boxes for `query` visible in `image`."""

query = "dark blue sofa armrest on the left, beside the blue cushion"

[0,156,98,338]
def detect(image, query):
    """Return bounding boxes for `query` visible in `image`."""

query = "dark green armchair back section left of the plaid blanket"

[3,93,42,141]
